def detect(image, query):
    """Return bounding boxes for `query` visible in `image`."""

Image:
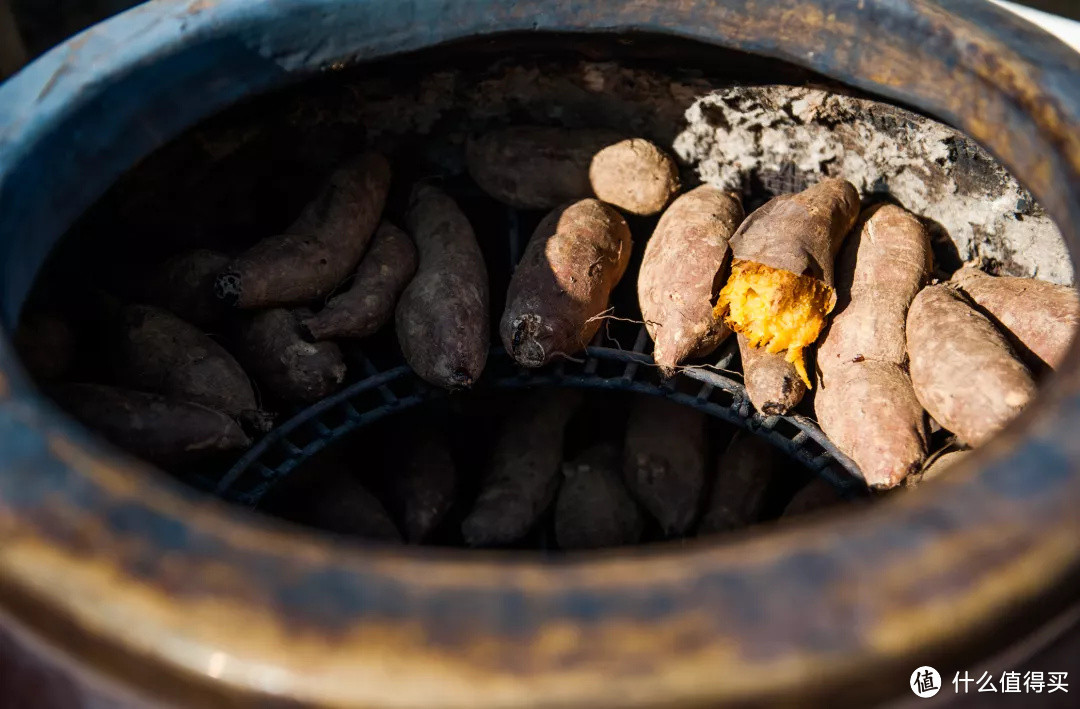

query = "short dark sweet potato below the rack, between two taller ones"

[555,444,644,549]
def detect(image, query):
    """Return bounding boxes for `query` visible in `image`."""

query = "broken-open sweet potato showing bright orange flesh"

[716,179,859,413]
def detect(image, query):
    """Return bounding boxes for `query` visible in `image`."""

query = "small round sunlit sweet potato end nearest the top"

[589,138,679,216]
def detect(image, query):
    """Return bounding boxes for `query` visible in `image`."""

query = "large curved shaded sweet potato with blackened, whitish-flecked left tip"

[215,153,390,308]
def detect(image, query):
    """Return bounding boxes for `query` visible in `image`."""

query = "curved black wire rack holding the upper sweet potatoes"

[208,197,866,508]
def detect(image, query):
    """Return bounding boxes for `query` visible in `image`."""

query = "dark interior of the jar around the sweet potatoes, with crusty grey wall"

[19,37,1071,550]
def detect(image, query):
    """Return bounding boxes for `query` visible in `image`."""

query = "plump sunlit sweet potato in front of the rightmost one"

[907,284,1036,445]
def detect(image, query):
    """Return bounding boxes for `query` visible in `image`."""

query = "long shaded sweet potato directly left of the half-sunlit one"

[395,186,490,389]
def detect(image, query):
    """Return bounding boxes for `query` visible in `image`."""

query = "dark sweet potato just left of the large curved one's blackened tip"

[146,249,230,327]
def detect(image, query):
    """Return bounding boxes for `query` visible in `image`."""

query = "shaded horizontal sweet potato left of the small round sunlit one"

[465,125,622,210]
